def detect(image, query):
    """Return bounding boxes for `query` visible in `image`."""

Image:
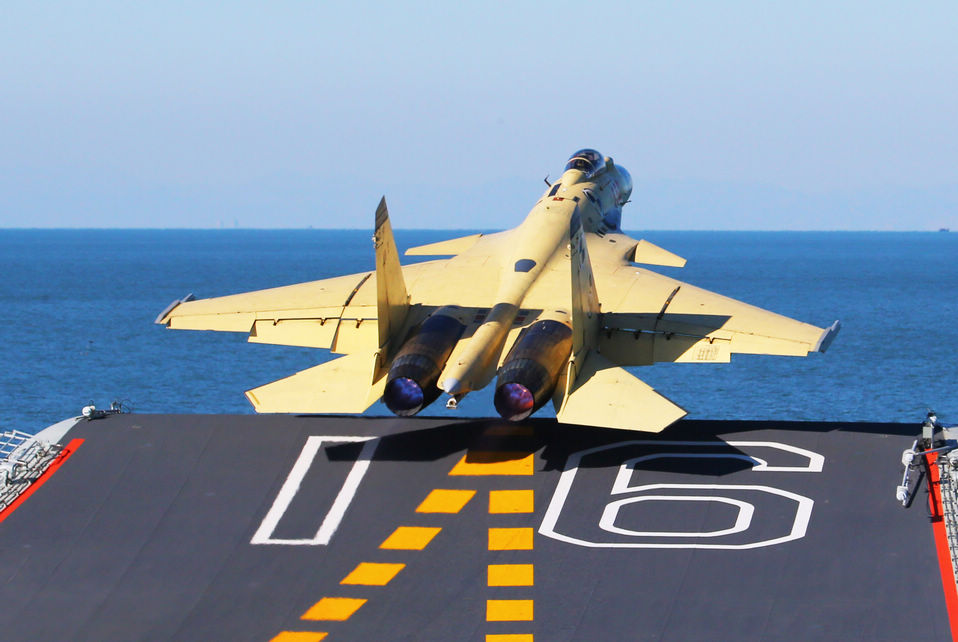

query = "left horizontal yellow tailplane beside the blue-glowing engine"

[246,352,386,414]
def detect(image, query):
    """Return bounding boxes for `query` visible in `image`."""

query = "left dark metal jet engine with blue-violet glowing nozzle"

[383,307,465,417]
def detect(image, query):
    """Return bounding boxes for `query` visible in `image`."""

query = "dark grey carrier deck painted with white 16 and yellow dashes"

[0,415,950,641]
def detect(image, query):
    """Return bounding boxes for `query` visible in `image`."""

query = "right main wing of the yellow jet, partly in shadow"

[596,266,840,365]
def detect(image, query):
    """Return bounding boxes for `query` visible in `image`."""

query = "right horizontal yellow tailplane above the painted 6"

[556,352,686,432]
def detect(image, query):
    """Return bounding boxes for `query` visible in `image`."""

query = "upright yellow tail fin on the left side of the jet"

[373,196,409,378]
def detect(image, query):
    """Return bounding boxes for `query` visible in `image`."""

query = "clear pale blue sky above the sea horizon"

[0,1,958,229]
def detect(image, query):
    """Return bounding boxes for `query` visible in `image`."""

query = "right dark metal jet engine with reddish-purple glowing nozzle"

[494,319,572,421]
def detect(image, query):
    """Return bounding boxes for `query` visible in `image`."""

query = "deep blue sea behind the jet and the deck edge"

[0,229,958,432]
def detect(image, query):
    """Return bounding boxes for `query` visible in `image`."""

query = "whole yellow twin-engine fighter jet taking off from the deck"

[156,149,840,432]
